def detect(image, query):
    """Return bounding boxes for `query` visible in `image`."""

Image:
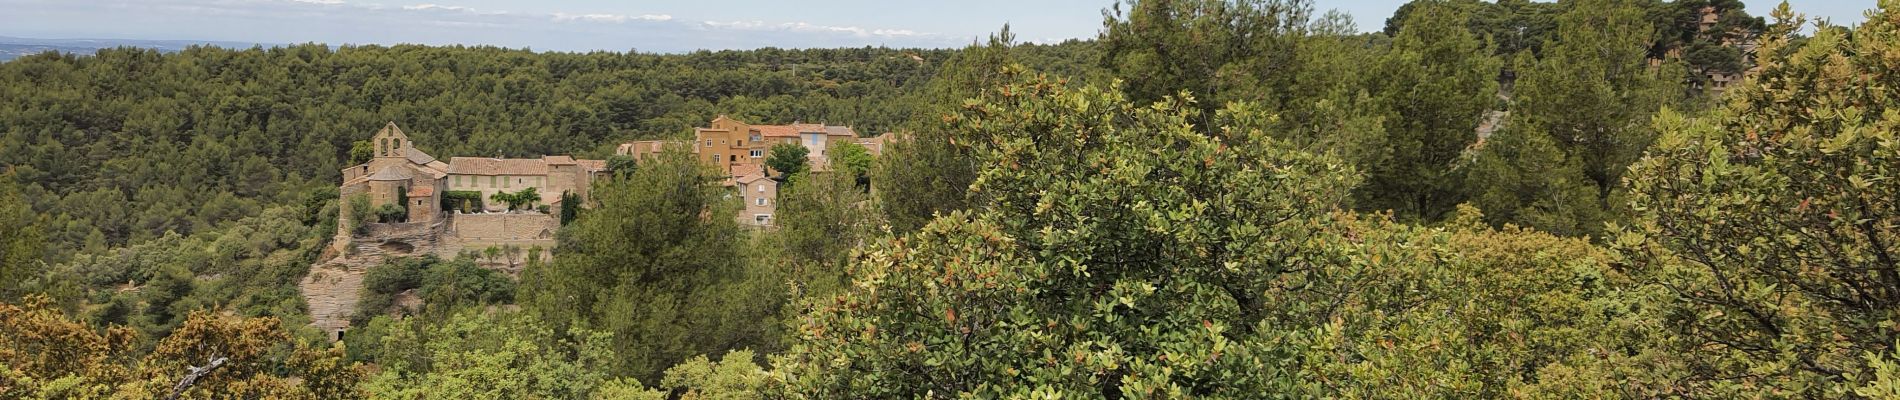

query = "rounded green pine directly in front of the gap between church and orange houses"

[517,150,783,381]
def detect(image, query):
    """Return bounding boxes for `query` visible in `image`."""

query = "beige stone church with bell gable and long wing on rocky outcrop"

[300,121,608,336]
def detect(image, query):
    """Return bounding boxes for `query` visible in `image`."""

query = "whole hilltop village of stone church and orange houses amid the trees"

[300,116,891,337]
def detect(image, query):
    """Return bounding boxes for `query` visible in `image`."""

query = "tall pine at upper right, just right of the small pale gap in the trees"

[1469,0,1682,235]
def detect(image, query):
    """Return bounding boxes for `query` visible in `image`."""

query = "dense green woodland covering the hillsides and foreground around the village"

[0,0,1900,398]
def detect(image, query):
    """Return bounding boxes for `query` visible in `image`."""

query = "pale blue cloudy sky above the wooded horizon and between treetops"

[0,0,1873,53]
